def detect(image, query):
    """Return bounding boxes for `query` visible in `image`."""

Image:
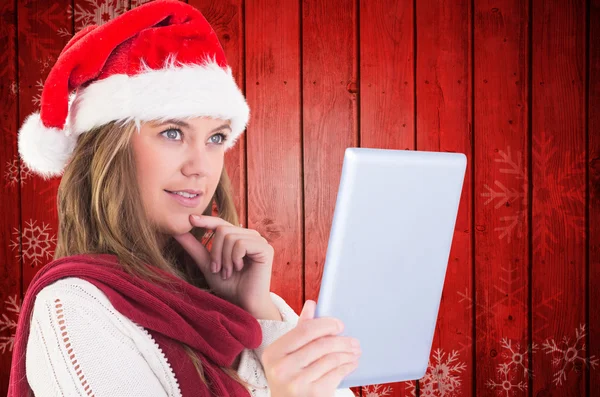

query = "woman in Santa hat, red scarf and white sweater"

[9,0,360,397]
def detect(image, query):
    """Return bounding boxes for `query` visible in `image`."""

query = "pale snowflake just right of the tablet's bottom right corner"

[407,348,467,397]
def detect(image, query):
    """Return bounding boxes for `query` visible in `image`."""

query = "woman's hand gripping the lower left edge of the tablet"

[261,300,360,397]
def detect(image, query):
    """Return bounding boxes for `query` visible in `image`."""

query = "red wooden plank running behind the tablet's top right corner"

[418,0,474,397]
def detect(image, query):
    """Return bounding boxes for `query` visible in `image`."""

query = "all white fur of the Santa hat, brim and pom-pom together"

[19,57,250,178]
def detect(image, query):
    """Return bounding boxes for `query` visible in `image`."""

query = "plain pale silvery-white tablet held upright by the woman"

[315,148,467,388]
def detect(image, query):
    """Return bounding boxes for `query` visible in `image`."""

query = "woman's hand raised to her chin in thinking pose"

[173,215,274,313]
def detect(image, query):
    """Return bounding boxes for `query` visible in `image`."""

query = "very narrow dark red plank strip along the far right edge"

[587,0,600,397]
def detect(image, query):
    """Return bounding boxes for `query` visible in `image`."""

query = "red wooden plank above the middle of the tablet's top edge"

[359,0,415,397]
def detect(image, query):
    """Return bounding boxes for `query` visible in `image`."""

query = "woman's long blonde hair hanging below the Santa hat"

[54,121,255,388]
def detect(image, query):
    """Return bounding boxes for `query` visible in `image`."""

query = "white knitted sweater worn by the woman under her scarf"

[26,277,354,397]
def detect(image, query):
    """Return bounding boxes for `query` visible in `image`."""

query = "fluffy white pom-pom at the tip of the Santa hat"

[19,112,77,178]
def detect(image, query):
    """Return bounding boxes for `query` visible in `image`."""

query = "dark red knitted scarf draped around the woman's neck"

[8,254,262,397]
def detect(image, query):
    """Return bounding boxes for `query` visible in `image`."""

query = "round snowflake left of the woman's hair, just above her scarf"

[11,219,56,266]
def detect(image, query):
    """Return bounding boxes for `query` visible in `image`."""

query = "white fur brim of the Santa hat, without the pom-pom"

[69,61,250,149]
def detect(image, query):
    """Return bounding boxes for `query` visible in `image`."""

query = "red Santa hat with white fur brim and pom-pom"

[18,0,250,177]
